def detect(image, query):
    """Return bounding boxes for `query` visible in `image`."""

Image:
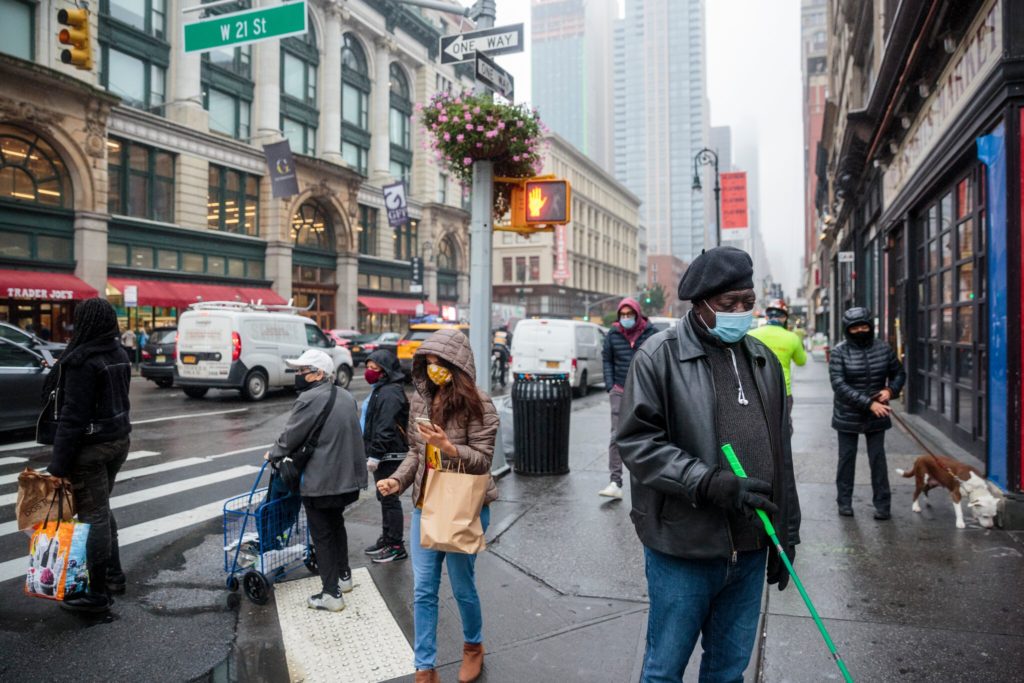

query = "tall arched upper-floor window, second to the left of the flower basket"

[341,33,370,175]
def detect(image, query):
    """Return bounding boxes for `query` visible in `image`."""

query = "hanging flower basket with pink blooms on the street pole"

[421,91,545,216]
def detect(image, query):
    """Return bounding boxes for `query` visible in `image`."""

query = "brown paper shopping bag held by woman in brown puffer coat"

[420,469,490,555]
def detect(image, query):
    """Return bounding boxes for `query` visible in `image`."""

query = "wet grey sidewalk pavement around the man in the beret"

[321,360,1024,683]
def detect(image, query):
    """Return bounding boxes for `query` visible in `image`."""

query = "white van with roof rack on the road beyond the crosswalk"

[174,301,352,400]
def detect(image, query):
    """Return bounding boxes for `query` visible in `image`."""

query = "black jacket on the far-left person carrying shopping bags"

[47,335,131,476]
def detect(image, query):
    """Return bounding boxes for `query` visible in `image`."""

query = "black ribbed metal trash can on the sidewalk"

[512,375,572,474]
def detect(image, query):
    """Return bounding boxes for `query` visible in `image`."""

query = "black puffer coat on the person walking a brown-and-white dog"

[828,339,906,434]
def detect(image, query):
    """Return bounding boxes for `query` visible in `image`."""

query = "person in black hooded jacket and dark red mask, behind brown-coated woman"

[361,348,409,563]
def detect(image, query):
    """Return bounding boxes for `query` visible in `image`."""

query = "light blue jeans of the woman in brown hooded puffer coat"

[409,505,490,669]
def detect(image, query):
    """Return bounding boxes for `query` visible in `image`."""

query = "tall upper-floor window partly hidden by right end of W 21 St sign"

[281,16,319,155]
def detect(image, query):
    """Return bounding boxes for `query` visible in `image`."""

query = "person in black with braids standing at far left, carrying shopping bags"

[40,298,131,612]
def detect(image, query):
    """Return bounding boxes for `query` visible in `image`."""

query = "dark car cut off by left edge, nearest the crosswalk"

[0,337,53,432]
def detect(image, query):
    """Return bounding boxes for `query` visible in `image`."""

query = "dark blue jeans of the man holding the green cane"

[640,547,767,683]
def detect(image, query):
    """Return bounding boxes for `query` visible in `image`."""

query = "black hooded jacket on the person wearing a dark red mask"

[362,348,409,461]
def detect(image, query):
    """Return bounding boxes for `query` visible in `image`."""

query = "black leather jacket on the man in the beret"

[617,315,800,560]
